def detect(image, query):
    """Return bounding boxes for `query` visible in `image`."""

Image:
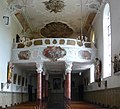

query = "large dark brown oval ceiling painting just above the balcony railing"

[40,22,73,38]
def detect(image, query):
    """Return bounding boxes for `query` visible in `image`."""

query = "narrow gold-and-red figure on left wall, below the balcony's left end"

[7,62,14,83]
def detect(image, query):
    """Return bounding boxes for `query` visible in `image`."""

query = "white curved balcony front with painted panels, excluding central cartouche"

[11,38,97,62]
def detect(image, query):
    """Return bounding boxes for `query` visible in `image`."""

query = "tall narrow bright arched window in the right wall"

[103,3,111,78]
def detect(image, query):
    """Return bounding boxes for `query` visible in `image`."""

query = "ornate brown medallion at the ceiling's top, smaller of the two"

[43,0,65,13]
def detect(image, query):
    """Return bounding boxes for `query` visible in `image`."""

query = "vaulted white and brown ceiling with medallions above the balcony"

[7,0,102,38]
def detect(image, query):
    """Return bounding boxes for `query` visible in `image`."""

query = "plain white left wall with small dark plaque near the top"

[0,0,22,91]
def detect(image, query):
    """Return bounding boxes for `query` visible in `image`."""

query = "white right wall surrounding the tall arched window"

[87,0,120,91]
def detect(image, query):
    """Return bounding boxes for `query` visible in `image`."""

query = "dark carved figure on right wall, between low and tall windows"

[95,58,101,82]
